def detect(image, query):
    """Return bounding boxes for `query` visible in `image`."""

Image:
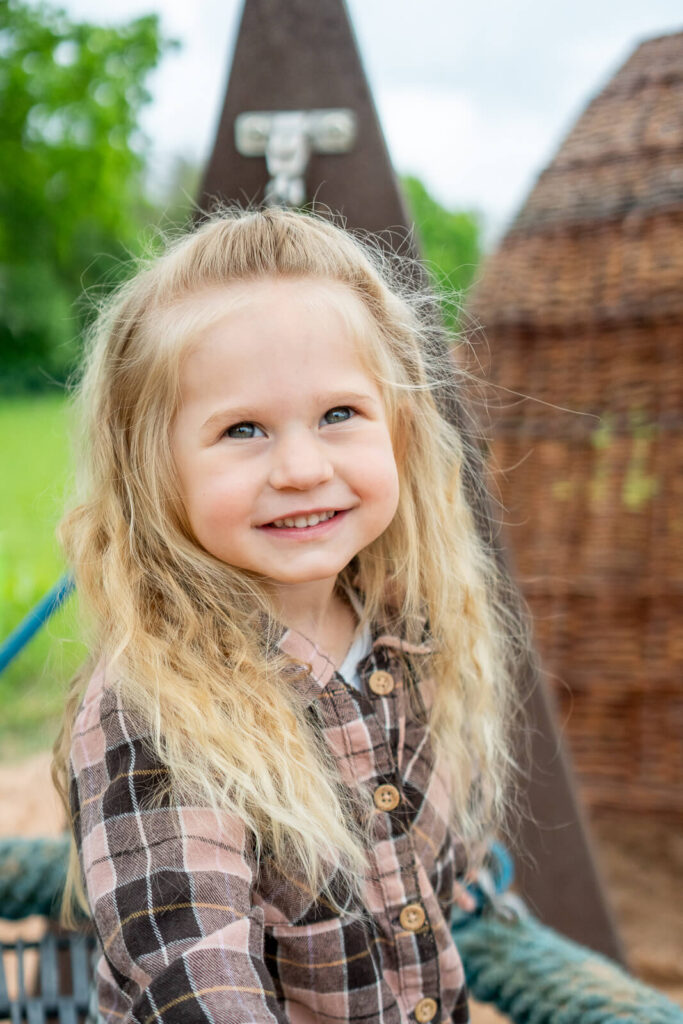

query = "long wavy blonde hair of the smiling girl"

[54,209,526,921]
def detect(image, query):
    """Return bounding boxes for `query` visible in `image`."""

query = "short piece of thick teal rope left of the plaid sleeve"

[0,839,69,921]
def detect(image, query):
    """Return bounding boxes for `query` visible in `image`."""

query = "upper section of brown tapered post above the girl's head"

[200,0,408,231]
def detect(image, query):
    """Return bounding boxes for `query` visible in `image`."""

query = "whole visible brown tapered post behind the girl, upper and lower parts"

[193,0,623,961]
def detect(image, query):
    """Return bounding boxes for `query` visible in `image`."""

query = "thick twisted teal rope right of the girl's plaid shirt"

[453,913,683,1024]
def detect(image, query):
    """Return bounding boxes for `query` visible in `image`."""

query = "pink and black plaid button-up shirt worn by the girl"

[72,614,469,1024]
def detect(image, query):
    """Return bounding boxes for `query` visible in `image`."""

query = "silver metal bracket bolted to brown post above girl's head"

[234,109,356,206]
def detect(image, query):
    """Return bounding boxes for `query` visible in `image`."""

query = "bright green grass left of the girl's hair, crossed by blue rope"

[0,396,85,760]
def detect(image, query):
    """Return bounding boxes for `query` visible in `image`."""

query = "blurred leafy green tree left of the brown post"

[0,0,173,390]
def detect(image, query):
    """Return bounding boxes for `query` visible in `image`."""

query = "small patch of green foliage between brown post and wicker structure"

[400,176,481,326]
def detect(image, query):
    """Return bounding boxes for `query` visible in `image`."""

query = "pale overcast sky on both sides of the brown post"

[58,0,683,242]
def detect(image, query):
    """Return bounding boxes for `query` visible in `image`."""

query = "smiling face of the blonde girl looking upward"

[172,279,398,598]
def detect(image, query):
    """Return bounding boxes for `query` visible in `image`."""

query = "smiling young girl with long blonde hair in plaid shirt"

[55,210,520,1024]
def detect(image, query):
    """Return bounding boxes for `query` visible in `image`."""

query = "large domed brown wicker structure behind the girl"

[471,33,683,813]
